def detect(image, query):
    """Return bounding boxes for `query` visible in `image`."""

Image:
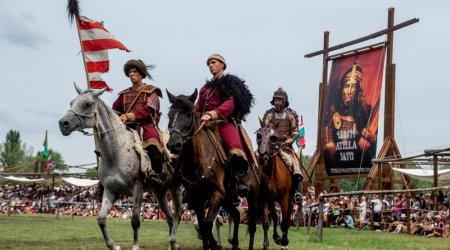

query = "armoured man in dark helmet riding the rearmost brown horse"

[262,87,303,203]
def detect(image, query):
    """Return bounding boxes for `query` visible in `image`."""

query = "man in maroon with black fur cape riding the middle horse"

[195,54,254,197]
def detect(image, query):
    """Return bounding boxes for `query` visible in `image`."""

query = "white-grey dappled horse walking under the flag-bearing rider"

[59,85,181,249]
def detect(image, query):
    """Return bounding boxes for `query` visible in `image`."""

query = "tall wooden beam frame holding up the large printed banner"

[304,8,419,197]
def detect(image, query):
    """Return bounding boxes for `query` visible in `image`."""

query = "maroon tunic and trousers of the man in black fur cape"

[195,86,247,159]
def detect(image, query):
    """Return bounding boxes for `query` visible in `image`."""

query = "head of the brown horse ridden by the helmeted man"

[256,119,280,166]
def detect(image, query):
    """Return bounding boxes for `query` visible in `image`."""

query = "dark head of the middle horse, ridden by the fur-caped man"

[166,89,197,154]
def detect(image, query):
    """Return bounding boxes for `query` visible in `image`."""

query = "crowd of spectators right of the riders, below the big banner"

[302,190,450,238]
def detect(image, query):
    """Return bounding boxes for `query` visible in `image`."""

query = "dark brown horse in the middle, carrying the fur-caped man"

[167,89,258,249]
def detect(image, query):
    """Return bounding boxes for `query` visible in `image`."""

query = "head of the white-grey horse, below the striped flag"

[58,83,106,136]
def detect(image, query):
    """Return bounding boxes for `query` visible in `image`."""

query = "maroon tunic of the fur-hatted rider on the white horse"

[112,85,162,149]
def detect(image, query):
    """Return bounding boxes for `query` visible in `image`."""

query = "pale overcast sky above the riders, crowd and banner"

[0,0,450,170]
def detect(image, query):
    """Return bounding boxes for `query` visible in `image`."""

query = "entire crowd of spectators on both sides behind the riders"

[0,184,450,238]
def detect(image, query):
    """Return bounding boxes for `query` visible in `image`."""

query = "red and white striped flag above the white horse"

[78,16,130,91]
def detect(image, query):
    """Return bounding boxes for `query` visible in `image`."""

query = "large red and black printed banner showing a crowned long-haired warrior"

[321,47,385,176]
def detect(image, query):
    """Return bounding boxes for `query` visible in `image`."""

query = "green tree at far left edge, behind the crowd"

[0,130,27,167]
